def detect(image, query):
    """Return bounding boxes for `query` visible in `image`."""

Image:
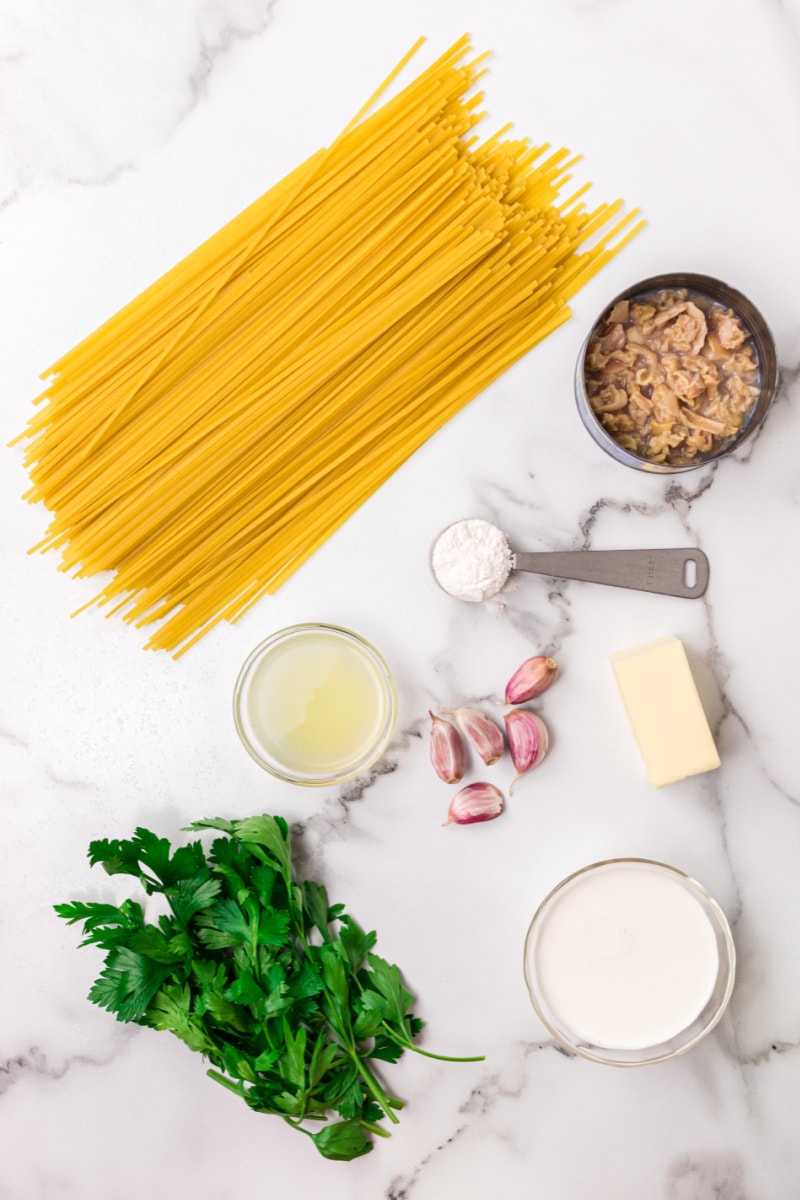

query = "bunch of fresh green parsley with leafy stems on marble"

[55,815,480,1159]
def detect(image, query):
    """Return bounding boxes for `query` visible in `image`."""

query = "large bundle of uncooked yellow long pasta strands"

[14,37,638,653]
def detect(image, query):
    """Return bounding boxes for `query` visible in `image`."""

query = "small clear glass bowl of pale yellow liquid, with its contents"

[234,624,397,787]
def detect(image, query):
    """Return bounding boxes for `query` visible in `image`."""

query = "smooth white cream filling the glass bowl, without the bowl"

[531,862,720,1050]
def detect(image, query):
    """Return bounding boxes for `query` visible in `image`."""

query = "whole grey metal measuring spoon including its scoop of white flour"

[431,518,709,601]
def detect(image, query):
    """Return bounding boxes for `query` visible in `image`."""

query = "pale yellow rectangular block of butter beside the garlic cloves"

[610,637,720,787]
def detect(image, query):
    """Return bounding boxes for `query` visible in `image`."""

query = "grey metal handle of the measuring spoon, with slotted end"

[513,548,709,600]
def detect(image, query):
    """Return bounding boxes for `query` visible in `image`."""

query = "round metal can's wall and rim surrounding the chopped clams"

[575,271,777,475]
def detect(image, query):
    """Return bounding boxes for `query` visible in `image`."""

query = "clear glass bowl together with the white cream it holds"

[524,858,735,1067]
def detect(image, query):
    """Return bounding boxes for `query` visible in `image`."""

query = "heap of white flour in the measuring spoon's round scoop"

[431,517,513,602]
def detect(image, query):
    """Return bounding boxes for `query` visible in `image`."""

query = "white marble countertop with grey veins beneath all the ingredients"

[0,0,800,1200]
